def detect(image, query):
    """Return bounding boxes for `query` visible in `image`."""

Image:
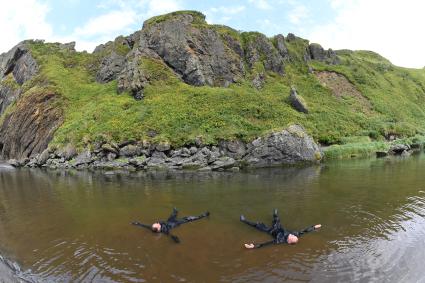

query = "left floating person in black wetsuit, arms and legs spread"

[131,208,210,243]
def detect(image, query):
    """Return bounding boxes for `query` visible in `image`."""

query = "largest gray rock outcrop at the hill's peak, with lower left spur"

[113,13,244,98]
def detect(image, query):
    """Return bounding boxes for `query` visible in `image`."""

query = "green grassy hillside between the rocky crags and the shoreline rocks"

[11,13,425,153]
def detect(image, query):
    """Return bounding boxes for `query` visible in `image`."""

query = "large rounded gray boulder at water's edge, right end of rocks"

[243,125,322,167]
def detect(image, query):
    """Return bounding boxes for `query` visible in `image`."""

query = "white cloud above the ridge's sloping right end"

[306,0,425,68]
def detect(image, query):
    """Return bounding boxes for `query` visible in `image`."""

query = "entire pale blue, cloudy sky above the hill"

[0,0,425,68]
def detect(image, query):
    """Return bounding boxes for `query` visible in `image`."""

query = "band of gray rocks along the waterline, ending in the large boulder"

[9,125,322,171]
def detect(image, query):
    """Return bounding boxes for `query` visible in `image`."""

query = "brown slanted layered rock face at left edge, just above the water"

[0,93,62,159]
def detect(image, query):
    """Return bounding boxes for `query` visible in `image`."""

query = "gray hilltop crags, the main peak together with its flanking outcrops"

[95,11,289,99]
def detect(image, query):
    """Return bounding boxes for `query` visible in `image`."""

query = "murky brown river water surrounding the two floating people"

[0,155,425,282]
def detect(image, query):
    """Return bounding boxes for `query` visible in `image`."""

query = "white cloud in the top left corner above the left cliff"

[0,0,53,53]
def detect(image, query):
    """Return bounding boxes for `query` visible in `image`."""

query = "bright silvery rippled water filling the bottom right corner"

[312,196,425,282]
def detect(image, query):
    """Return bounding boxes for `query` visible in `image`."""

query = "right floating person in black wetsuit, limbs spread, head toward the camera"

[240,209,322,249]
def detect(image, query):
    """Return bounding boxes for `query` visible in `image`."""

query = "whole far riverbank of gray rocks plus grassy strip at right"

[8,133,425,172]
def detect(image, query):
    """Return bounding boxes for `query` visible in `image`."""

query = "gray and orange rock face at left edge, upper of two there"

[0,42,39,115]
